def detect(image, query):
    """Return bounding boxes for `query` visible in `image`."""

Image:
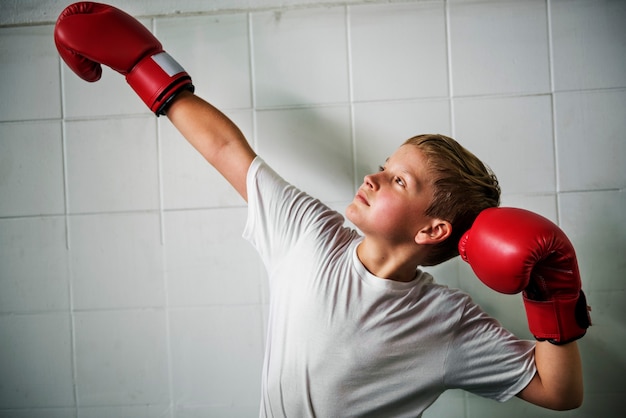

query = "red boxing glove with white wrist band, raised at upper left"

[54,2,194,115]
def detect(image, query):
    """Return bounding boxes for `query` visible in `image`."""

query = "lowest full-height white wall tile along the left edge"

[0,313,74,409]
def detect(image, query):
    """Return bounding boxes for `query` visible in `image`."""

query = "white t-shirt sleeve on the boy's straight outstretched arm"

[243,157,343,267]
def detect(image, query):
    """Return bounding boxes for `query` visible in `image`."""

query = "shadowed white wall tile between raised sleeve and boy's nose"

[257,106,354,202]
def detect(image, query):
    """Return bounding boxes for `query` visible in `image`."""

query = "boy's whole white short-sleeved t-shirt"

[244,157,536,418]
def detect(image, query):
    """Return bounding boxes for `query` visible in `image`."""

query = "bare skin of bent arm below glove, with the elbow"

[519,341,583,410]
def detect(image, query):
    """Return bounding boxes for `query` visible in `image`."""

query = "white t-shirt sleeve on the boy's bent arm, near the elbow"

[445,297,537,402]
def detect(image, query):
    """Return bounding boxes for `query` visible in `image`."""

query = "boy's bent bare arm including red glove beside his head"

[459,208,591,410]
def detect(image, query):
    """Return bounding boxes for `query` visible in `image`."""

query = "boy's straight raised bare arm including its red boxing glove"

[54,2,255,200]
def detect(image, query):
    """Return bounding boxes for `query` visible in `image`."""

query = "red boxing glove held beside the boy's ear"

[459,208,591,344]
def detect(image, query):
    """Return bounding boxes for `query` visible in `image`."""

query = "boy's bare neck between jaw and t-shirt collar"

[356,237,421,282]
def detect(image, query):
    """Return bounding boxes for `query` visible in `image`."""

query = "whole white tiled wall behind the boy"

[0,0,626,418]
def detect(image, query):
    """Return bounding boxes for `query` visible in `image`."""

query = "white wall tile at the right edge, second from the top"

[555,90,626,191]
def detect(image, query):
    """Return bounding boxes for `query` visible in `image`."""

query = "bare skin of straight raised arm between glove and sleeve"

[167,92,256,200]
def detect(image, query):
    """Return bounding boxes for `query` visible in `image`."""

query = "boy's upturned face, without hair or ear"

[346,145,433,244]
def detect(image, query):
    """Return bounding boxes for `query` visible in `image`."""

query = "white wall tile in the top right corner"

[549,0,626,90]
